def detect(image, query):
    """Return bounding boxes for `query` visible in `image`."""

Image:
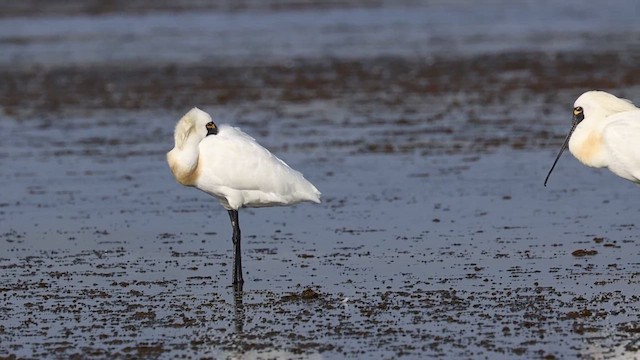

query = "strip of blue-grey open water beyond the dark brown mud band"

[0,0,640,66]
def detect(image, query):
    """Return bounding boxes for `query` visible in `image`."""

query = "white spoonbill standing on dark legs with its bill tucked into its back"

[167,108,320,286]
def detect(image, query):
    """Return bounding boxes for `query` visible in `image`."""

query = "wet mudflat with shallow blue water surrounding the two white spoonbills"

[0,1,640,359]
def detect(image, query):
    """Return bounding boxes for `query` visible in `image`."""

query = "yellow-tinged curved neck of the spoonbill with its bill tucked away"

[167,136,201,186]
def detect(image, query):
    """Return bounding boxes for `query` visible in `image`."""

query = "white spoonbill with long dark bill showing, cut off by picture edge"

[544,91,640,186]
